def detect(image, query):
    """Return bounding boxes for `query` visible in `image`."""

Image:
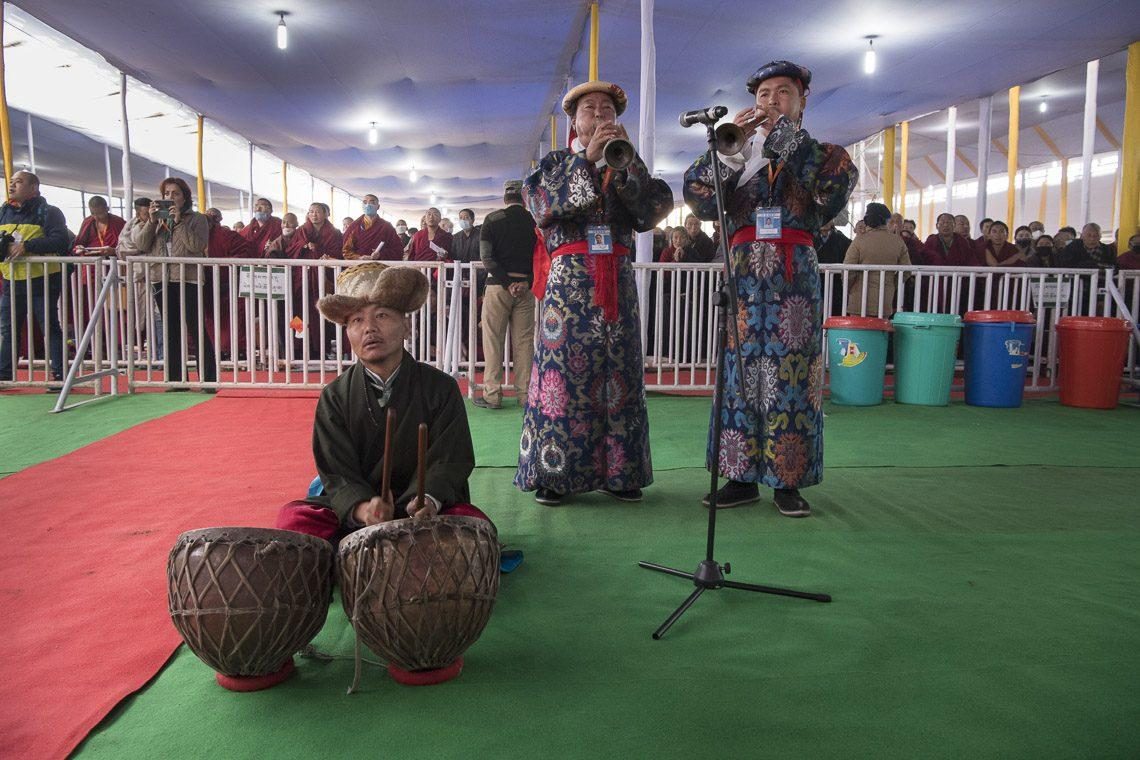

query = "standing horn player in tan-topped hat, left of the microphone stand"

[514,81,673,506]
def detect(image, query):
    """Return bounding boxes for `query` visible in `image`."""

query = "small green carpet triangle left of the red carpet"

[0,393,212,477]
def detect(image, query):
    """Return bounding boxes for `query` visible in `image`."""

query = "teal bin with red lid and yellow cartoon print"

[823,317,893,407]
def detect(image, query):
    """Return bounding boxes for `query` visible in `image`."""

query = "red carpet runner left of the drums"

[0,397,316,760]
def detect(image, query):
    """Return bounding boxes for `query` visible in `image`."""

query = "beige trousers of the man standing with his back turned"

[482,285,535,404]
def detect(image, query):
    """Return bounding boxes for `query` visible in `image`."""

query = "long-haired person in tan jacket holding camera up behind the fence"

[136,177,218,383]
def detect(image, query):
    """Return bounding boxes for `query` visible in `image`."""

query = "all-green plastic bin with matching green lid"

[891,311,962,407]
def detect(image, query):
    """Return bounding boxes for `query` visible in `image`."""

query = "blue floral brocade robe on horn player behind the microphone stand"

[684,117,858,489]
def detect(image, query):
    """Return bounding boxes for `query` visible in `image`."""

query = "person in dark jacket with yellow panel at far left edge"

[0,171,68,381]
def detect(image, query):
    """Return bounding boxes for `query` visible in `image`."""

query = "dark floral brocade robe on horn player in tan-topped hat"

[514,146,673,495]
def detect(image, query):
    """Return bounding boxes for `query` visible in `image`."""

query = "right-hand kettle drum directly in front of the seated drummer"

[339,516,499,685]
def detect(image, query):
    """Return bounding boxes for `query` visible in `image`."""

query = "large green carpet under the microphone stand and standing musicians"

[79,397,1140,758]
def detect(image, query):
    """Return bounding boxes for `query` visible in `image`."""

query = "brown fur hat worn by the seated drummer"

[317,261,428,325]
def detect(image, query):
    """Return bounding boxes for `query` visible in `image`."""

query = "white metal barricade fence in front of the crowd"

[3,256,1140,394]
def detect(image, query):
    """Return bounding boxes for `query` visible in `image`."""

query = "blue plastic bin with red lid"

[962,311,1036,408]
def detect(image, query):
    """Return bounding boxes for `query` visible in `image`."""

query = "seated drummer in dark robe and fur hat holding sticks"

[277,262,487,541]
